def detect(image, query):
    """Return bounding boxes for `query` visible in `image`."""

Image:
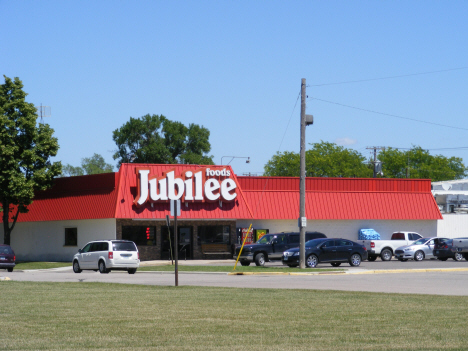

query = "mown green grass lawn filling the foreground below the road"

[0,281,468,351]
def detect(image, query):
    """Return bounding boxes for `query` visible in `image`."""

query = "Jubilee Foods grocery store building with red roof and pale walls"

[0,164,442,261]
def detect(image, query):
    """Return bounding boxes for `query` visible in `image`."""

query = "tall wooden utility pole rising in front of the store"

[299,78,306,269]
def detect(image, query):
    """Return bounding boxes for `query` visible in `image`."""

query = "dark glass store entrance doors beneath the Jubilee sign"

[161,227,193,260]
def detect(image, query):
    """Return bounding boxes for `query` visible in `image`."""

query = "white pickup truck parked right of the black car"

[357,232,422,261]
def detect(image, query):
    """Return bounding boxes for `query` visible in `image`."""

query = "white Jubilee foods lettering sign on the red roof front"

[133,167,237,206]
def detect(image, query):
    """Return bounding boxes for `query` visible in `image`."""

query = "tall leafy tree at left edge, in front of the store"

[0,76,62,244]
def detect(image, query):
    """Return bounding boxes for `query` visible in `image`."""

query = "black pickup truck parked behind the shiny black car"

[233,232,327,266]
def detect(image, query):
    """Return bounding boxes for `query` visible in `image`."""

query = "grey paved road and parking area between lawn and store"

[0,260,468,296]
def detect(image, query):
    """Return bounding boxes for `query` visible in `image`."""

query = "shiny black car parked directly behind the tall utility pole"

[281,238,367,268]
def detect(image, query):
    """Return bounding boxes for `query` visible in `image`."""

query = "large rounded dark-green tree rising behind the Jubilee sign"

[113,114,214,165]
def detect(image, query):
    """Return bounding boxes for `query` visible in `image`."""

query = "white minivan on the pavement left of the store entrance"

[73,240,140,274]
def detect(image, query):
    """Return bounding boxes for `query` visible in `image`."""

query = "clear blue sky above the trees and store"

[0,0,468,175]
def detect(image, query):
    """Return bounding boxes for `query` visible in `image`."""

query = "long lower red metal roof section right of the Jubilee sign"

[238,177,442,220]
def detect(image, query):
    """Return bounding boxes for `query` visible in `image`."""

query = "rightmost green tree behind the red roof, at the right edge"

[379,146,468,182]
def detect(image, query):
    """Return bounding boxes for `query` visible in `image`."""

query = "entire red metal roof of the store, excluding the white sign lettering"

[0,164,442,222]
